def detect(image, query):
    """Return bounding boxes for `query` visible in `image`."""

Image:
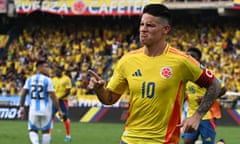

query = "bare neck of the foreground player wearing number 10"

[144,42,167,57]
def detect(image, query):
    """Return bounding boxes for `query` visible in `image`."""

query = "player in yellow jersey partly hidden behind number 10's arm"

[183,47,226,144]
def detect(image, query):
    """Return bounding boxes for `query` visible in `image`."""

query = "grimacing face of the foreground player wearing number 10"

[139,13,170,45]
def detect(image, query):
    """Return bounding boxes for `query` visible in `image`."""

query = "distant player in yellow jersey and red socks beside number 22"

[53,67,72,142]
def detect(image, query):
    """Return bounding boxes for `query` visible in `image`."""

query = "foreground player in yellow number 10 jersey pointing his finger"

[88,4,220,144]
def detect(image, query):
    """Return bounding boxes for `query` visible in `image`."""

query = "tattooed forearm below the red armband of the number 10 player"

[197,78,220,117]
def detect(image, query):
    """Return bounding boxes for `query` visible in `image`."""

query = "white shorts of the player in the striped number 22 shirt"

[28,107,52,131]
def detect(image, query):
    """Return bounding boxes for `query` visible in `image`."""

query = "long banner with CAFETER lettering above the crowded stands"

[14,0,161,15]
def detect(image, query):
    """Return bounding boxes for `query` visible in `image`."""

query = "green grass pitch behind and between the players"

[0,120,240,144]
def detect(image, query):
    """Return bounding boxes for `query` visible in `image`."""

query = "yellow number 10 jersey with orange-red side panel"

[107,45,212,143]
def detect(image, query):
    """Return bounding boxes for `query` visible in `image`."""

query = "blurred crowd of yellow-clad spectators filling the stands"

[0,14,240,103]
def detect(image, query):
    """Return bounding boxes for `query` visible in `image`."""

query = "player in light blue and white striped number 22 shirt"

[20,60,63,144]
